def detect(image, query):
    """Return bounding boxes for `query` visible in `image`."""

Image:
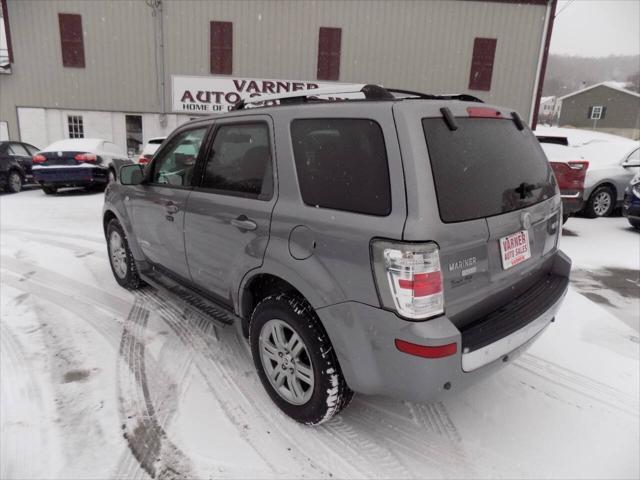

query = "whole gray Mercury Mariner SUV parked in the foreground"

[103,85,571,425]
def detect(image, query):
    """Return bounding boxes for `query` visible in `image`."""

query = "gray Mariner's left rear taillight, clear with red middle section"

[371,240,444,320]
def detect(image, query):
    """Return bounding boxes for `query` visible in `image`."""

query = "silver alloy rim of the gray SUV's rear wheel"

[259,319,314,405]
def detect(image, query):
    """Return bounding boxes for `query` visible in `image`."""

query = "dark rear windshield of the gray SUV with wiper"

[422,118,555,222]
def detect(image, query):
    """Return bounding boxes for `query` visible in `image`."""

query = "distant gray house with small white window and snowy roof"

[558,82,640,140]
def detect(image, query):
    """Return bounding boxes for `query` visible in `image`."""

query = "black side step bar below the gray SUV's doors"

[140,268,241,327]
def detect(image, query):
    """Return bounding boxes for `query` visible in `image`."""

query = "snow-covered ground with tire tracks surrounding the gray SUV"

[0,190,640,478]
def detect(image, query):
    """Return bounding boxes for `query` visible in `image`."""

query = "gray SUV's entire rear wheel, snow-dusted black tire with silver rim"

[249,294,353,425]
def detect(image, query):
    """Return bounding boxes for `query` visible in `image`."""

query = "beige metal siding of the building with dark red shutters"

[0,0,546,140]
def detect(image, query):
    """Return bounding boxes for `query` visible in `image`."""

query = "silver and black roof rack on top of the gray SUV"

[231,84,484,110]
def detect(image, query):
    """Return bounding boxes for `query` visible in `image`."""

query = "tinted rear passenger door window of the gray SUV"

[202,123,273,199]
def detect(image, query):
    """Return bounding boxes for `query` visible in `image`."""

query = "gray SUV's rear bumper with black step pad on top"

[317,248,571,401]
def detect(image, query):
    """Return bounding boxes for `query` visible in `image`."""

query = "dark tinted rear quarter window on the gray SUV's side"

[291,118,391,215]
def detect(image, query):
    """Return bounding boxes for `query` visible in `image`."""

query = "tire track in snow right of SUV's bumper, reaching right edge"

[514,353,639,417]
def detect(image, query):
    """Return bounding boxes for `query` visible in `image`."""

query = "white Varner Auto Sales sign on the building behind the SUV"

[171,75,360,114]
